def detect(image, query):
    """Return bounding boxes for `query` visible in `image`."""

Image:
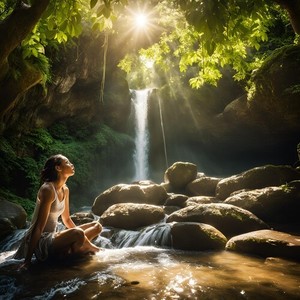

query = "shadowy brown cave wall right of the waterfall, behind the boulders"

[149,46,300,179]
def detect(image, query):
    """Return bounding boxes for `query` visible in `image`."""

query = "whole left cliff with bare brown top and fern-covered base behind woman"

[0,33,133,206]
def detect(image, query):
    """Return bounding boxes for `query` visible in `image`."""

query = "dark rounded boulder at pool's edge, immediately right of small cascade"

[171,222,227,251]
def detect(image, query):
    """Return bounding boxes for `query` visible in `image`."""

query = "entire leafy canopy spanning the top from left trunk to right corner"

[0,0,300,113]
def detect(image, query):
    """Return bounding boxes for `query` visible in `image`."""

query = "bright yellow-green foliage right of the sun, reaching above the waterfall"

[120,1,298,88]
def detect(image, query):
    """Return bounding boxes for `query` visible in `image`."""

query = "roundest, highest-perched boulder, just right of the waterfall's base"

[164,162,197,191]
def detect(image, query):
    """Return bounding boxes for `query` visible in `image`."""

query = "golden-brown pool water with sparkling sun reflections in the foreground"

[0,247,300,300]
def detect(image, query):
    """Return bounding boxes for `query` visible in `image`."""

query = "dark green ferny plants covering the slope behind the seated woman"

[0,120,132,214]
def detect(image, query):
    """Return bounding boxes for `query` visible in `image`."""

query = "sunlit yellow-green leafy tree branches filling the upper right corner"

[121,0,300,88]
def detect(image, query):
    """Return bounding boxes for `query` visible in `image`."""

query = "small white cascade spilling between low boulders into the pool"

[111,223,172,248]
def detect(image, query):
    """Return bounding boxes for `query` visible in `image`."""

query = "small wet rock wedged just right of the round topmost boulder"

[186,176,221,196]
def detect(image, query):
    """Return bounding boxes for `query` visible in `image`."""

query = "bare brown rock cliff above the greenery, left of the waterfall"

[2,33,130,131]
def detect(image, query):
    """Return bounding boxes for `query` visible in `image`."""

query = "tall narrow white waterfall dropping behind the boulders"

[132,89,151,180]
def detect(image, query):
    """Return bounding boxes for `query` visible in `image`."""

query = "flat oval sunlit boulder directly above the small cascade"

[99,203,165,230]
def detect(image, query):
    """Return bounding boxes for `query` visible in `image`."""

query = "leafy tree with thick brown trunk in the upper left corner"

[0,0,127,117]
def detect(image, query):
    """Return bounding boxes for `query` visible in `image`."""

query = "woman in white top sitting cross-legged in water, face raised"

[14,154,102,269]
